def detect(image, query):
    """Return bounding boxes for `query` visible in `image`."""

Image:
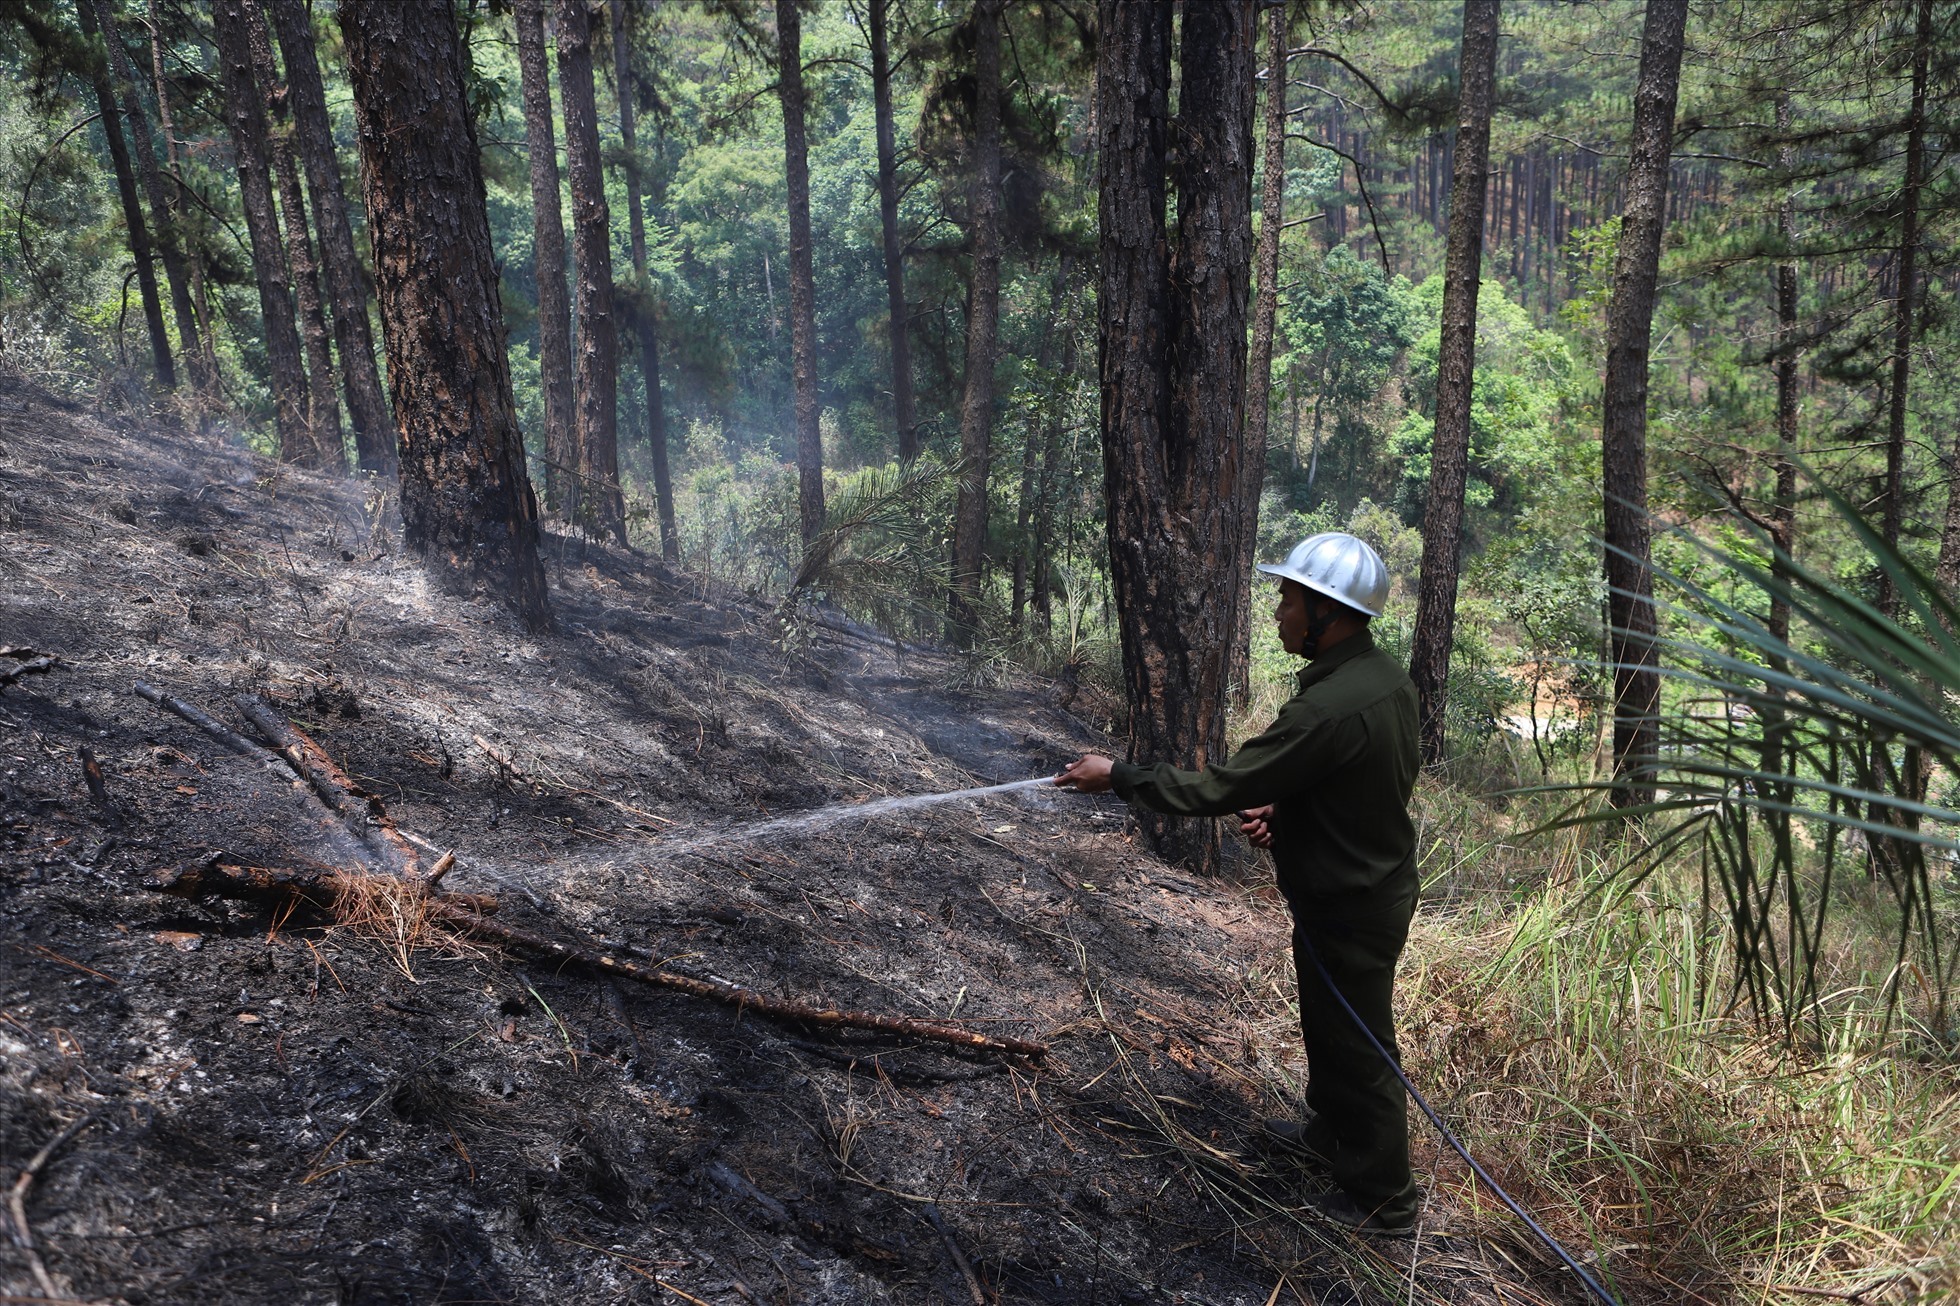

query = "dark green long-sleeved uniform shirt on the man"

[1109,629,1421,900]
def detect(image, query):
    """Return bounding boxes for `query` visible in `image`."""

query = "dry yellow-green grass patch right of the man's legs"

[1399,784,1960,1302]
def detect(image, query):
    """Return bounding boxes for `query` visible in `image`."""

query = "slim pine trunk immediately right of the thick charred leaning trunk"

[517,0,578,522]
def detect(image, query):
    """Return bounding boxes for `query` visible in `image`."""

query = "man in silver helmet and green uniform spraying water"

[1054,531,1421,1233]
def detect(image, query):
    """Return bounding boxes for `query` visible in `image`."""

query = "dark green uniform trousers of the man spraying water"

[1290,878,1417,1224]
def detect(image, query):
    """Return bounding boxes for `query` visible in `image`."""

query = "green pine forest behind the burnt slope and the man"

[0,0,1960,1294]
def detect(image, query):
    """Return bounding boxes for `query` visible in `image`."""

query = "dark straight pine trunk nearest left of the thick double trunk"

[947,0,1005,649]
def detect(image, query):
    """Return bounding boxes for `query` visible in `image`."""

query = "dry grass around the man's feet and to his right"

[1103,768,1960,1306]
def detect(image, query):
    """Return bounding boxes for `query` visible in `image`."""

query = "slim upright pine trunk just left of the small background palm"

[776,0,823,543]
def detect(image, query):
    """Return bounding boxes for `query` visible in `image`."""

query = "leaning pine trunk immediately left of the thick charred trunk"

[269,0,396,478]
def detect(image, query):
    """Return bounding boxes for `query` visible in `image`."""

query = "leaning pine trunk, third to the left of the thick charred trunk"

[212,0,316,463]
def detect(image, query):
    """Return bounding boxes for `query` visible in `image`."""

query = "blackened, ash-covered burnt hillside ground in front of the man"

[0,368,1574,1306]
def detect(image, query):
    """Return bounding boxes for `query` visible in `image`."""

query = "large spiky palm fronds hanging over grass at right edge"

[1552,478,1960,1037]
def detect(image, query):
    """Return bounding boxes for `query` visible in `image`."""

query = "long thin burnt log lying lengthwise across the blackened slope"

[143,857,1049,1057]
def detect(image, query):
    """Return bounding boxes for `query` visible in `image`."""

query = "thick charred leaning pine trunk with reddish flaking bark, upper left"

[339,0,549,629]
